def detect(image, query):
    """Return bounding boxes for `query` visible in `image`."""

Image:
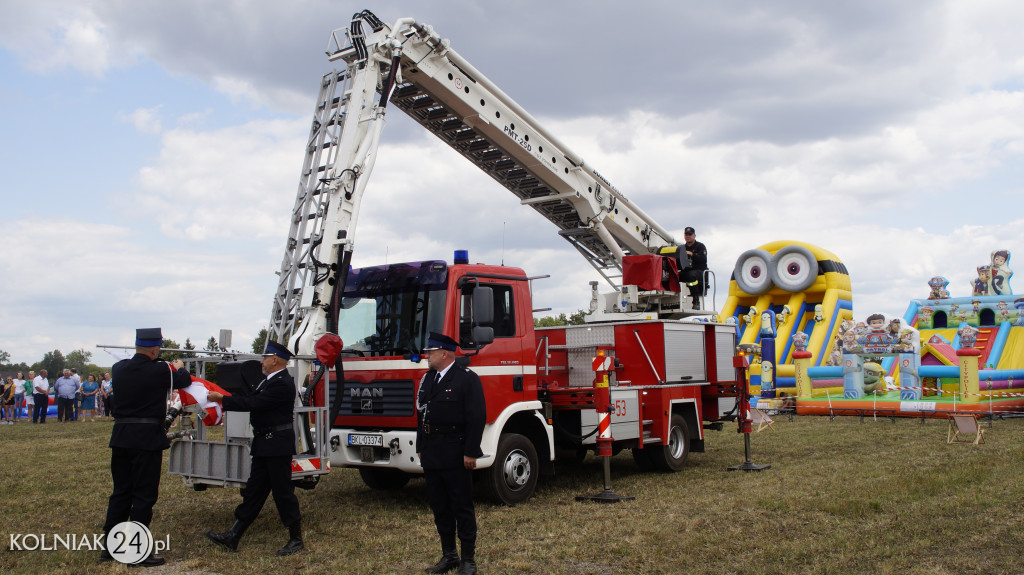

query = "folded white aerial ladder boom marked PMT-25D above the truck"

[269,11,700,353]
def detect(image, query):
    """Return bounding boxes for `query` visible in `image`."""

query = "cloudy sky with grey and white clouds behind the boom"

[0,0,1024,364]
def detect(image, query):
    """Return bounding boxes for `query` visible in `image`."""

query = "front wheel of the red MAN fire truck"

[483,433,540,505]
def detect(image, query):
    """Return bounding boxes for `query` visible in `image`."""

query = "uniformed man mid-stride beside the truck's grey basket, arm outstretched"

[206,342,304,556]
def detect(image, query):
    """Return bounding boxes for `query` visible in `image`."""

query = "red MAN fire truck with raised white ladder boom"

[171,11,739,504]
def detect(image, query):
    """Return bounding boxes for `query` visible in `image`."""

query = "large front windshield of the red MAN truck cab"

[338,261,447,357]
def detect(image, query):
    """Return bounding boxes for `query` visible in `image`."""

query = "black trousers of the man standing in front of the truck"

[423,468,476,541]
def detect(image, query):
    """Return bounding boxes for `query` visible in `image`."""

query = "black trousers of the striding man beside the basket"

[234,455,302,527]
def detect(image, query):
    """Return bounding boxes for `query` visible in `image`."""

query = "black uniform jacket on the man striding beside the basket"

[223,369,295,457]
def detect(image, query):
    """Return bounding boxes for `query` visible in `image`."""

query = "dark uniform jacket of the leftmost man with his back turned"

[110,353,191,450]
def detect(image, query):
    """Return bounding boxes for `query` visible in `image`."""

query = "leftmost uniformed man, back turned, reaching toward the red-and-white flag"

[99,327,191,567]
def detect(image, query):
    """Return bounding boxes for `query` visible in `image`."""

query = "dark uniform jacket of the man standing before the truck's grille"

[416,365,487,470]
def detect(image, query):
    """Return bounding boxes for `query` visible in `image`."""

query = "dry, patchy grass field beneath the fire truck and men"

[0,416,1024,575]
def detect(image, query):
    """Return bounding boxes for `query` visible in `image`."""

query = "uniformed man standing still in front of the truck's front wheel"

[416,333,486,575]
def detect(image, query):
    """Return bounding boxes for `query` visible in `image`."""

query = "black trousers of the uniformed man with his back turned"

[103,447,164,532]
